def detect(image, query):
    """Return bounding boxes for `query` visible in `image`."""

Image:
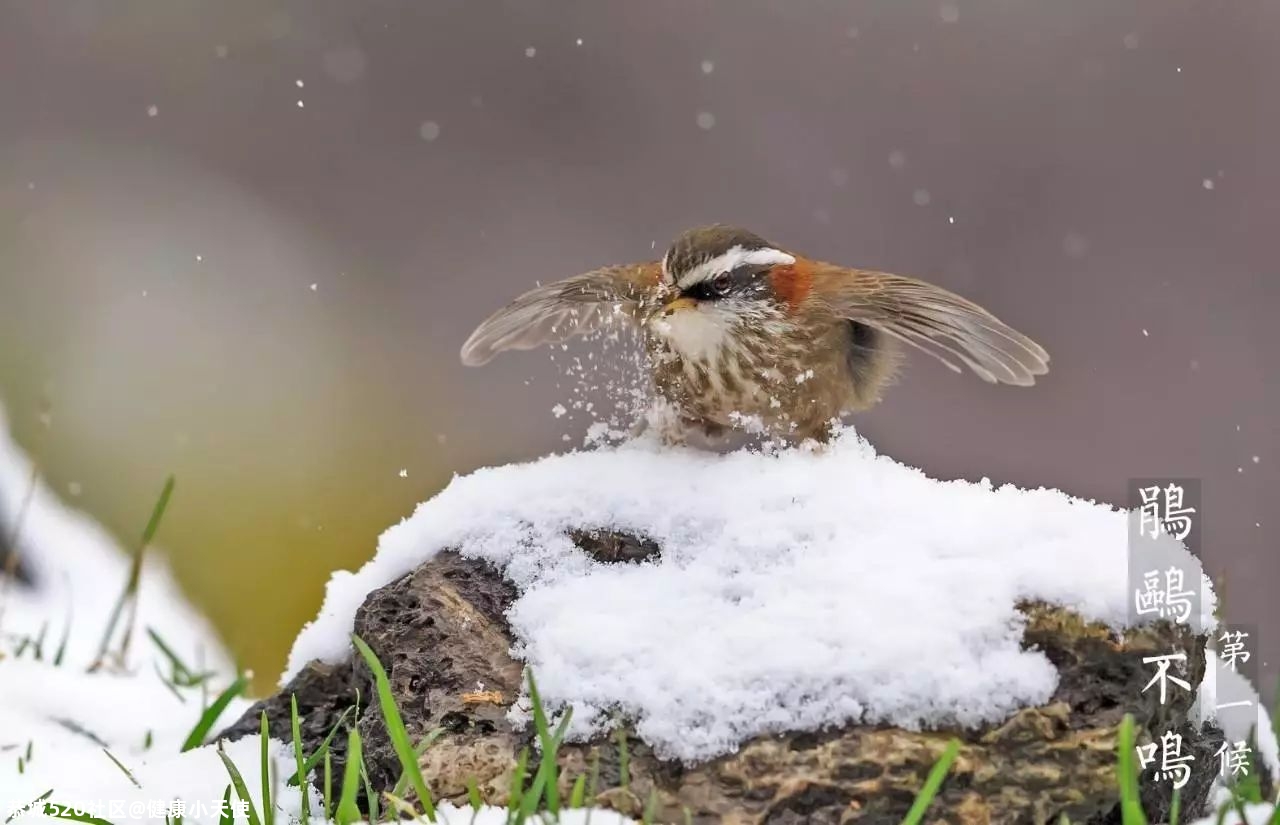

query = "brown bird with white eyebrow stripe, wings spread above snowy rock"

[462,225,1048,441]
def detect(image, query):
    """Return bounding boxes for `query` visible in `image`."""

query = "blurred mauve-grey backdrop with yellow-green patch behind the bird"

[0,0,1280,686]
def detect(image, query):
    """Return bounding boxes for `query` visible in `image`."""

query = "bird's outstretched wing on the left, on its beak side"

[462,261,662,367]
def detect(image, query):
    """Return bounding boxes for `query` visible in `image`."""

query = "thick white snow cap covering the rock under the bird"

[290,430,1213,761]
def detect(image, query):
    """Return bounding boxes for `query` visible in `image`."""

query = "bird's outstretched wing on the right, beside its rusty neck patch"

[819,267,1048,386]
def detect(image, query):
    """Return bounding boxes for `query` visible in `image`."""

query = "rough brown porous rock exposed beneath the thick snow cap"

[219,532,1222,824]
